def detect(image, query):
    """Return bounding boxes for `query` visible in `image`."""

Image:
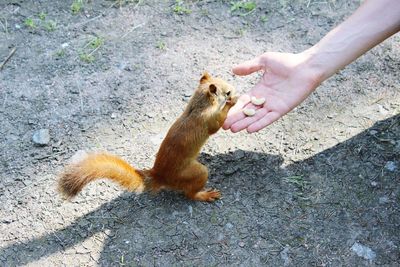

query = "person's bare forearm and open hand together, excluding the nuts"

[223,0,400,133]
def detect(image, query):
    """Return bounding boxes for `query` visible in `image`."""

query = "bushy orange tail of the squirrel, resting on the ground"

[58,153,145,199]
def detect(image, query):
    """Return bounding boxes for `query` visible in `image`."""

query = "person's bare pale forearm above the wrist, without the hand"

[303,0,400,83]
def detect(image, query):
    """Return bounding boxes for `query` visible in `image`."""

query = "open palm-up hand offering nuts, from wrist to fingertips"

[223,52,320,133]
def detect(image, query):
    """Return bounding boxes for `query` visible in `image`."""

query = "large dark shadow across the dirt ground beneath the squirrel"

[0,115,400,266]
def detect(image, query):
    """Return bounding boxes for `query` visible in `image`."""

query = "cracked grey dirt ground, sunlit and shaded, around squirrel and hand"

[0,0,400,266]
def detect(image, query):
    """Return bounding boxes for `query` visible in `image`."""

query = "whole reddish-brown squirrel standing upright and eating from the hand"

[58,72,238,202]
